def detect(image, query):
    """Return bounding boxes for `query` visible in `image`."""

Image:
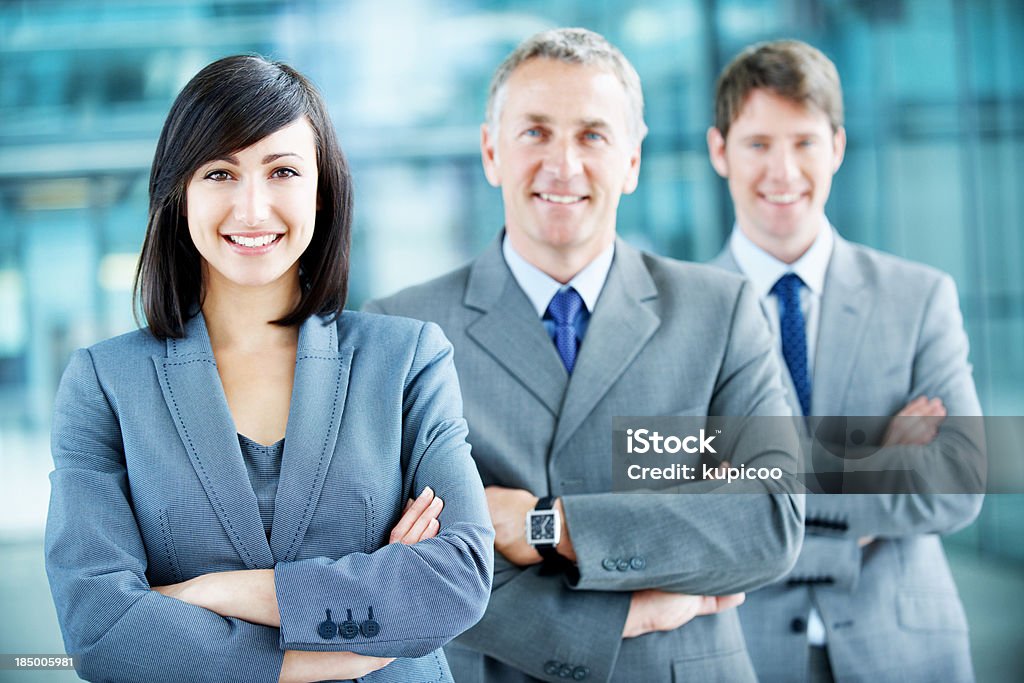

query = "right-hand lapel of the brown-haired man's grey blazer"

[811,233,877,416]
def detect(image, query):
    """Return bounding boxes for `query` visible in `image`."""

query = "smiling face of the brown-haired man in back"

[708,89,846,262]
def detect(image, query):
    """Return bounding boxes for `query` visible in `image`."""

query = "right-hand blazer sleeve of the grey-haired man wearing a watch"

[562,283,804,595]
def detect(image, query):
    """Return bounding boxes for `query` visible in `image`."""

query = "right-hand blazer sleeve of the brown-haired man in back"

[807,274,986,540]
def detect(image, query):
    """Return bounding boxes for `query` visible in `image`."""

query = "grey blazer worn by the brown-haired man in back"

[713,234,982,683]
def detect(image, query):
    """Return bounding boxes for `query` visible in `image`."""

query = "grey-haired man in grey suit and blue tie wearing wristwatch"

[369,29,803,683]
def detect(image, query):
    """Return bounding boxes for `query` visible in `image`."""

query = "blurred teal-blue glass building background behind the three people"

[0,0,1024,681]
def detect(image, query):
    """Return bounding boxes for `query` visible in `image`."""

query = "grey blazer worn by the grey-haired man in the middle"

[370,240,803,683]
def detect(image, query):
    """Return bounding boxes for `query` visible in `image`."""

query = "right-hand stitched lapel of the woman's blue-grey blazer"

[268,315,352,562]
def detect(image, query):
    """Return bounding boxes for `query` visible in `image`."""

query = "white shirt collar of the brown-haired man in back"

[729,220,836,298]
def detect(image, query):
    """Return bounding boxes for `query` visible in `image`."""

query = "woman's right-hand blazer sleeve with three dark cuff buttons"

[274,324,494,657]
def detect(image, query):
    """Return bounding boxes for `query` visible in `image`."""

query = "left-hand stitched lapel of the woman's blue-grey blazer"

[153,313,273,569]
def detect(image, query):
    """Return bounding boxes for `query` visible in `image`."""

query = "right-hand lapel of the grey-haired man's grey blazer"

[545,240,662,455]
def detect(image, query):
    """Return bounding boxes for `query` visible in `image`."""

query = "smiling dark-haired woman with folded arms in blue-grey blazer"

[46,56,493,682]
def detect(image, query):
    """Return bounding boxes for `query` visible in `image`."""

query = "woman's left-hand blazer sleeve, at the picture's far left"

[45,350,284,683]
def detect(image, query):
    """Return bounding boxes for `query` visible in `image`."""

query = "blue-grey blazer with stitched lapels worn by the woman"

[46,311,494,683]
